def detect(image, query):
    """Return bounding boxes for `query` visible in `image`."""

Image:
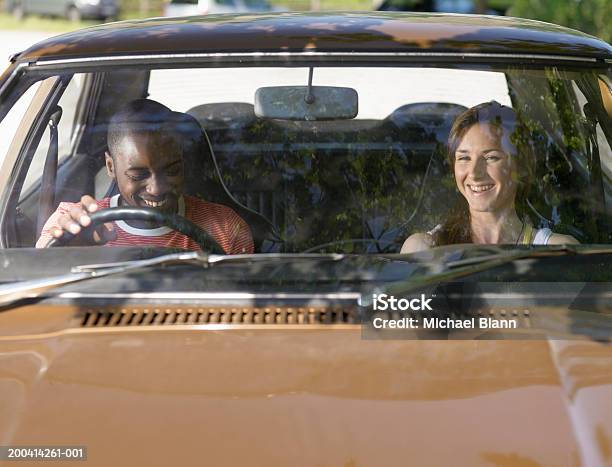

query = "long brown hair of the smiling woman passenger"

[433,101,535,245]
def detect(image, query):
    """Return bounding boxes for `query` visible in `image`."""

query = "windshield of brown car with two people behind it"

[0,63,612,254]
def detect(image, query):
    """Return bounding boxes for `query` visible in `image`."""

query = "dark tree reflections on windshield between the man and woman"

[209,115,450,253]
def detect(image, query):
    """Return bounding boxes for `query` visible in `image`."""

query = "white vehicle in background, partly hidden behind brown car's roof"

[164,0,275,16]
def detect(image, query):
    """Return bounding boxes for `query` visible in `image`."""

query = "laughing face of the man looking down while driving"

[106,132,184,213]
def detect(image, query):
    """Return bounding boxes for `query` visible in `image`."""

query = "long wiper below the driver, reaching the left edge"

[0,251,345,308]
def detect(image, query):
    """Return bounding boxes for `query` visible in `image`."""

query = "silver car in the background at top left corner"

[4,0,119,21]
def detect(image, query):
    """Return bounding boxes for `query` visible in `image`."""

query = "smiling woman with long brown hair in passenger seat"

[401,101,578,253]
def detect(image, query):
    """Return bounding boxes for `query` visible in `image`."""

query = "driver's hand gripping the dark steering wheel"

[51,195,117,246]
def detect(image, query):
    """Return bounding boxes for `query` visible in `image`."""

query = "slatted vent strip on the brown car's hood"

[80,307,359,328]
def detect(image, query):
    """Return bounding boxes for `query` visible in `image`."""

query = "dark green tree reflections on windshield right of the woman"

[509,69,607,243]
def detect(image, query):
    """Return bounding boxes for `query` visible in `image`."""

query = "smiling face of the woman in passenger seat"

[455,123,517,212]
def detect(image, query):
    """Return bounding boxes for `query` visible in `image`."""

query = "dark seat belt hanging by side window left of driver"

[36,106,62,238]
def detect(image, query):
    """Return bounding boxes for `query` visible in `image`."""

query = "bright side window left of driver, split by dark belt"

[20,74,85,199]
